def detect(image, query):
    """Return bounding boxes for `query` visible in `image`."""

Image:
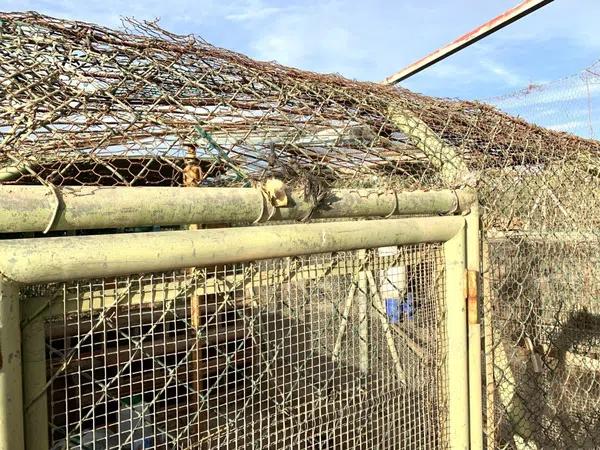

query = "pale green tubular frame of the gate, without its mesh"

[0,189,481,450]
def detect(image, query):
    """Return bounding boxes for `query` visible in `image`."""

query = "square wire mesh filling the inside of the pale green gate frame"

[25,244,447,449]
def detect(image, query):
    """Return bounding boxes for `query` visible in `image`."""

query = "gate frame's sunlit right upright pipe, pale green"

[444,223,469,449]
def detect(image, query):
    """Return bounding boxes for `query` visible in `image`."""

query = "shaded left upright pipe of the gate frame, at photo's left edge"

[0,278,25,450]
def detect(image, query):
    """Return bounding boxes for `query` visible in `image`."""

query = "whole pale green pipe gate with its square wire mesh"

[0,188,481,449]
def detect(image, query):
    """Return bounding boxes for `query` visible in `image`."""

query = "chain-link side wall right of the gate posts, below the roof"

[481,166,600,449]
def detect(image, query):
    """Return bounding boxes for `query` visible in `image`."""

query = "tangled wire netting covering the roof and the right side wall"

[0,9,600,449]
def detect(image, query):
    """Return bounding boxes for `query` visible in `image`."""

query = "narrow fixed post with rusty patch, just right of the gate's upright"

[465,200,483,450]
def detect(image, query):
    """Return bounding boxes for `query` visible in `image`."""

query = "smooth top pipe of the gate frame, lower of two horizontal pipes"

[0,216,464,283]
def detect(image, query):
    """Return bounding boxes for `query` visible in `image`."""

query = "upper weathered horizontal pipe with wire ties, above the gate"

[0,185,473,233]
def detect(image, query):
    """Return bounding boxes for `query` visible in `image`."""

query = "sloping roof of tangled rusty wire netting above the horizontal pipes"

[0,13,600,187]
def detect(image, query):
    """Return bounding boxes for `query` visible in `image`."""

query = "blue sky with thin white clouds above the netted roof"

[0,0,600,108]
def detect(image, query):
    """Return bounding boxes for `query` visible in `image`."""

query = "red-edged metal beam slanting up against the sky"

[382,0,553,84]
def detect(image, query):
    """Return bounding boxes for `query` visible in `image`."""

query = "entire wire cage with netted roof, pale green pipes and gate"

[0,13,600,449]
